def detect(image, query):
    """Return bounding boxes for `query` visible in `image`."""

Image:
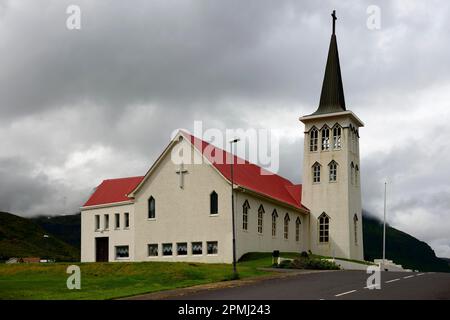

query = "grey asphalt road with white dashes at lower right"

[171,271,450,300]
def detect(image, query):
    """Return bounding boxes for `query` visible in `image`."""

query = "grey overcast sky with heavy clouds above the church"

[0,0,450,257]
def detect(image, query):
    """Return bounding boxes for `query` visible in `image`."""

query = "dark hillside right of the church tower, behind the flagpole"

[363,212,450,272]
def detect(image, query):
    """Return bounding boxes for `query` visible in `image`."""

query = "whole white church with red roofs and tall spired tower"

[81,12,363,263]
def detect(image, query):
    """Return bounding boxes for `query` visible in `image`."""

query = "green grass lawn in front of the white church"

[0,253,296,299]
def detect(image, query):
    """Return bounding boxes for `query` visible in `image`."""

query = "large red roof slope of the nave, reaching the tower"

[182,131,308,210]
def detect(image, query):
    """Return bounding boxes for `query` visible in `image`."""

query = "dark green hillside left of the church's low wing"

[0,212,80,261]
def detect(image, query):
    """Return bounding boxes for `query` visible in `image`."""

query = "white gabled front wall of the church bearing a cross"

[131,140,232,263]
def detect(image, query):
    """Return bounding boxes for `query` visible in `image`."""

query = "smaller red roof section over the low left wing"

[84,177,144,207]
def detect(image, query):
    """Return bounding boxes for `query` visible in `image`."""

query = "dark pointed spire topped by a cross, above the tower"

[313,10,346,115]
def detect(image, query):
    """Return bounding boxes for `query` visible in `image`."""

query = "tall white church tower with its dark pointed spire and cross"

[300,11,364,260]
